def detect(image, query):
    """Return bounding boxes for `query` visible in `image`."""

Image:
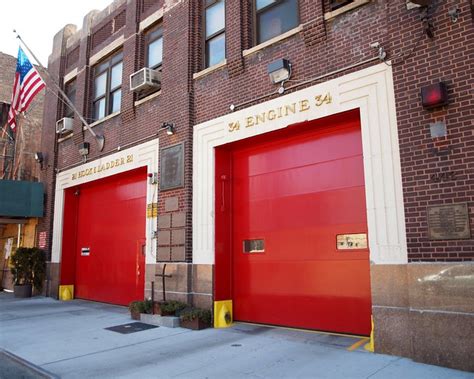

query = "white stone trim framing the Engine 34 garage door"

[193,63,407,264]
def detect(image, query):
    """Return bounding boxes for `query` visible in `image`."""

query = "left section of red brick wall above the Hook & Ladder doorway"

[39,1,192,261]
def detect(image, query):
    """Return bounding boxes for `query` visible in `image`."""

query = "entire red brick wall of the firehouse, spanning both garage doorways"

[39,0,474,261]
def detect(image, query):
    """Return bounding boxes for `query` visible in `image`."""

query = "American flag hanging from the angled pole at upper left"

[8,47,45,130]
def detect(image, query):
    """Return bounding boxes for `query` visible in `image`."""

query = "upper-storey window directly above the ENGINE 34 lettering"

[255,0,299,44]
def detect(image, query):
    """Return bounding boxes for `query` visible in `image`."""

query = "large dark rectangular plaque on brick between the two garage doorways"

[160,143,184,191]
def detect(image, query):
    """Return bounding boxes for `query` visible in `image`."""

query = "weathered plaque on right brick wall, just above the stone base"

[428,203,471,240]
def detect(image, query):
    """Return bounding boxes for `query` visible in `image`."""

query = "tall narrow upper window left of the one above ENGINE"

[204,0,225,67]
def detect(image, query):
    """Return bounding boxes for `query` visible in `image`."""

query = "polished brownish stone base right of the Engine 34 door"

[371,263,474,371]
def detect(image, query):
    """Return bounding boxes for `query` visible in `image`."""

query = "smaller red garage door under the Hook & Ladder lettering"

[75,168,147,305]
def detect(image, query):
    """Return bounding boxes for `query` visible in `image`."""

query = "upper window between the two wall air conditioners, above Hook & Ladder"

[92,52,123,120]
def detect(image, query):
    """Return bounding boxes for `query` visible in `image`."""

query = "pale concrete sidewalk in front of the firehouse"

[0,293,474,379]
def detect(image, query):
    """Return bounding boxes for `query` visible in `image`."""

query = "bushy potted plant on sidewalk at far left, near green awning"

[11,247,46,297]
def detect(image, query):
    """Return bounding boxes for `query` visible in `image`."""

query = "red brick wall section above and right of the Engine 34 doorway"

[194,0,474,261]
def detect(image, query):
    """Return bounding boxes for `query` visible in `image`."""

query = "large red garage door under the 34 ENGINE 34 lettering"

[231,114,371,335]
